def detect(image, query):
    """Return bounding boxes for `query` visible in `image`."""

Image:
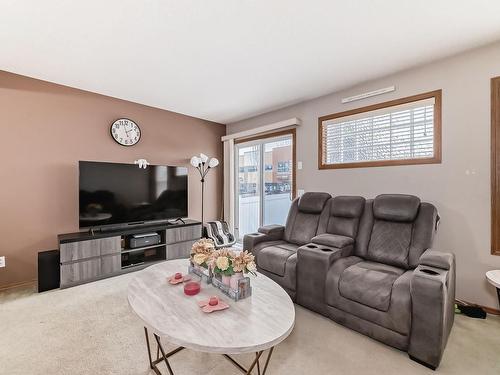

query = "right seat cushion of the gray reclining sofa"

[339,262,404,311]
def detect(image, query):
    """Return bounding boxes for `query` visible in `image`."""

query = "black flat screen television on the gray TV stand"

[79,161,188,228]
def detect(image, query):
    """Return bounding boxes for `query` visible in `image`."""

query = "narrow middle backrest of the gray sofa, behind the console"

[318,196,365,238]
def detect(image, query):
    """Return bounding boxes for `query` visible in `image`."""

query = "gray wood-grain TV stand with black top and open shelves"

[57,219,201,288]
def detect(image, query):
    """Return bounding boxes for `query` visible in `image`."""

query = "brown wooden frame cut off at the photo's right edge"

[491,77,500,255]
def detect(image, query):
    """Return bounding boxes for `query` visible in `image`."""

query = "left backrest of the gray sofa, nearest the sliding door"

[284,192,331,245]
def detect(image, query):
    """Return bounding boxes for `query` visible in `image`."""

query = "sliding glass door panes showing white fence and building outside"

[235,131,295,241]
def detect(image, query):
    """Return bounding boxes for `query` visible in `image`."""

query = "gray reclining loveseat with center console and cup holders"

[243,193,455,369]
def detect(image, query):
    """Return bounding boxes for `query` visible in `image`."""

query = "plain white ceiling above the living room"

[0,0,500,123]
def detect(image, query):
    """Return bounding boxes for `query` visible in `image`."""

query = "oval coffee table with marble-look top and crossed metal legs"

[128,259,295,375]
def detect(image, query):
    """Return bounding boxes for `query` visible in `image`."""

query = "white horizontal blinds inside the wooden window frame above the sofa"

[321,97,435,165]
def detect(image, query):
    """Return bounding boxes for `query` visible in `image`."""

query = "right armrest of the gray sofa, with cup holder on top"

[408,250,455,369]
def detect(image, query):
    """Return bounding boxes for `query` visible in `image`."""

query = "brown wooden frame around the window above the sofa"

[318,90,442,169]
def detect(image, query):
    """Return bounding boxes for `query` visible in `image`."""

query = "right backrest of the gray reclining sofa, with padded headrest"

[354,194,438,269]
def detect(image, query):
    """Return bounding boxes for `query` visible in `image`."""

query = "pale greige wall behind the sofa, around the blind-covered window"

[227,43,500,308]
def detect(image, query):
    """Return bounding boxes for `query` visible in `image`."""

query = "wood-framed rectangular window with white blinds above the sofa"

[319,91,441,168]
